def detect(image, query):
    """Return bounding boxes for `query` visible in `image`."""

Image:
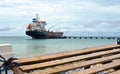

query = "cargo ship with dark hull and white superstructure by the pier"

[26,15,63,39]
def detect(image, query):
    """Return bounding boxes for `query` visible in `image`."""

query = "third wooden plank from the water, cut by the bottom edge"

[33,54,120,74]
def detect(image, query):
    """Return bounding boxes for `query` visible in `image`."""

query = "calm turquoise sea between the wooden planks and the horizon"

[0,37,116,58]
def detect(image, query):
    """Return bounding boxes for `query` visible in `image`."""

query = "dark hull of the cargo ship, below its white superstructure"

[26,31,63,39]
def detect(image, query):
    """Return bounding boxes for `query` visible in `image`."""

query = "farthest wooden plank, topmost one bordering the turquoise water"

[14,45,120,64]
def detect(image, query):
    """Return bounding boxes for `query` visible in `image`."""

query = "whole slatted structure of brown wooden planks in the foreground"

[12,45,120,74]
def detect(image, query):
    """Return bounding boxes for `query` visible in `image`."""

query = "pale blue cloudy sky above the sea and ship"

[0,0,120,36]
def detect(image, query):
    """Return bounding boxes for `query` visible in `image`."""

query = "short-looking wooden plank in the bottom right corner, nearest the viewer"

[73,60,120,74]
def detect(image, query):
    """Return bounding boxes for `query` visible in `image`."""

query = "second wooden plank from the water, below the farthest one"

[20,49,120,71]
